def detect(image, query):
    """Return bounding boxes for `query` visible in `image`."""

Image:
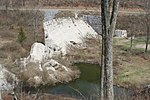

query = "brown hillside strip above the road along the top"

[0,0,146,8]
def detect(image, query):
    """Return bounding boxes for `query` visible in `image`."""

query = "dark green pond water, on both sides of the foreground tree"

[42,63,133,100]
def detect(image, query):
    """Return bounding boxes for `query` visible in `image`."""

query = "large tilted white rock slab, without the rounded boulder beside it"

[43,18,97,55]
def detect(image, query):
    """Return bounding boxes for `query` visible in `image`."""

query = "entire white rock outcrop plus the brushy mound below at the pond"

[18,18,97,86]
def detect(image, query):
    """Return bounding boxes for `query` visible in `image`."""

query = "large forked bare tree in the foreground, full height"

[100,0,120,100]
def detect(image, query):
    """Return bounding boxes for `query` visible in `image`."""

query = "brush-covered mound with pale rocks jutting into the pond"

[22,59,79,87]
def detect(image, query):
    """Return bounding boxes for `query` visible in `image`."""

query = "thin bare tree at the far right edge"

[144,0,150,52]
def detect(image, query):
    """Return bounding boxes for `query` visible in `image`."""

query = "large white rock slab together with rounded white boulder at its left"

[28,18,97,62]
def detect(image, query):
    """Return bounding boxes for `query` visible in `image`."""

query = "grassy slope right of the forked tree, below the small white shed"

[114,37,150,87]
